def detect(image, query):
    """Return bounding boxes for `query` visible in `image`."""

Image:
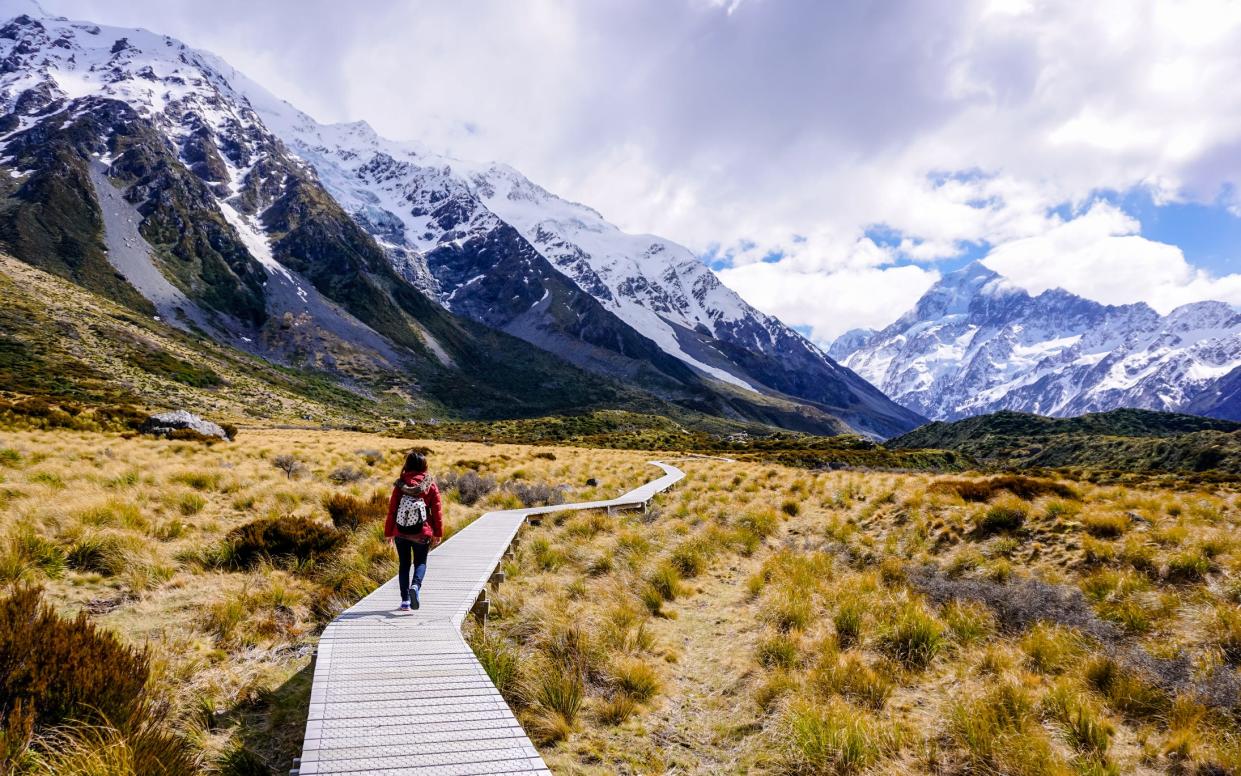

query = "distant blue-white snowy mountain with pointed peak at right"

[829,262,1241,420]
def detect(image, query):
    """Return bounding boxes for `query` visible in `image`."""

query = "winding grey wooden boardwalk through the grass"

[290,461,685,776]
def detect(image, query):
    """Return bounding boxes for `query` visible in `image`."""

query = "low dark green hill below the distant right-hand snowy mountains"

[887,410,1241,474]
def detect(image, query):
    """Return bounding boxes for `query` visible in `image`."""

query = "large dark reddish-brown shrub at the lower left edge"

[0,587,149,749]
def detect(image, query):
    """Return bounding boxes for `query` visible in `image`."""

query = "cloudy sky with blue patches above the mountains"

[33,0,1241,344]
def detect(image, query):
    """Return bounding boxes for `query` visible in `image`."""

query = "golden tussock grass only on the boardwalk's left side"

[0,431,648,774]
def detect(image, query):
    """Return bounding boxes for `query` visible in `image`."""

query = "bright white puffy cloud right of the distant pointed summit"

[983,202,1241,313]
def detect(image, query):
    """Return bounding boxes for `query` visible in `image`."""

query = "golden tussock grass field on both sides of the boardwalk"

[0,428,1241,775]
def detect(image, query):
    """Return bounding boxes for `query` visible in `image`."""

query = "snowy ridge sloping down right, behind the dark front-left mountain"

[247,76,918,436]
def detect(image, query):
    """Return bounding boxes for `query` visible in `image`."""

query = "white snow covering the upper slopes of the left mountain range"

[0,9,830,399]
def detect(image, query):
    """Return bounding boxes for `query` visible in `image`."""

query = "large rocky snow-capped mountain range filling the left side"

[0,0,921,436]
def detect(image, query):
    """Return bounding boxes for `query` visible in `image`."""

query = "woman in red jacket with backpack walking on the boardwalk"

[383,453,444,612]
